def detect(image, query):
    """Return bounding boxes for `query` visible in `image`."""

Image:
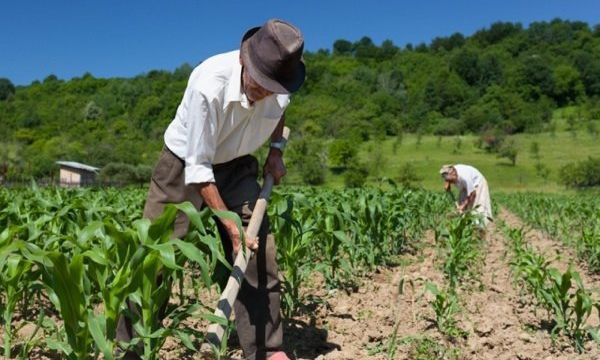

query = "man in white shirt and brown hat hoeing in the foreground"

[117,19,305,360]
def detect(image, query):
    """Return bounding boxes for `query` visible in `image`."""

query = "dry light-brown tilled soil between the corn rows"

[4,209,600,360]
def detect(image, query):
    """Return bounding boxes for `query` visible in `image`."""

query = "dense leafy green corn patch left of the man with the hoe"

[0,189,232,359]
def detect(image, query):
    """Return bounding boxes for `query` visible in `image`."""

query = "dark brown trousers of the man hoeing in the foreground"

[116,147,283,360]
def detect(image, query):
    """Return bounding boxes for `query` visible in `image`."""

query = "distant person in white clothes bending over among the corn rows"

[440,164,493,226]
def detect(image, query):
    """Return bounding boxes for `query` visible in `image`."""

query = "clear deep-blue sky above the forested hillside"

[0,0,600,85]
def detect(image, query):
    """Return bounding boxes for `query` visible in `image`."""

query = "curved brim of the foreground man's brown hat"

[240,26,306,94]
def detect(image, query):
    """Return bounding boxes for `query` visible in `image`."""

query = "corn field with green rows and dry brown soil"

[0,187,600,360]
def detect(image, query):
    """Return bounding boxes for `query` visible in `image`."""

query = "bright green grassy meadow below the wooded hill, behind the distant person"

[316,130,600,192]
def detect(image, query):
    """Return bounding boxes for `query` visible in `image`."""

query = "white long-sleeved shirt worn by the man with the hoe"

[165,50,290,185]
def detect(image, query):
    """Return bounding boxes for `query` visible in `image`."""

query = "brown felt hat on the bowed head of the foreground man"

[240,19,306,94]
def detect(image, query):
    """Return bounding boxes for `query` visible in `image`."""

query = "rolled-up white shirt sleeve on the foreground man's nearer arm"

[185,91,219,185]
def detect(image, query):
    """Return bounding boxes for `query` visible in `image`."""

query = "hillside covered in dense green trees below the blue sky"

[0,20,600,178]
